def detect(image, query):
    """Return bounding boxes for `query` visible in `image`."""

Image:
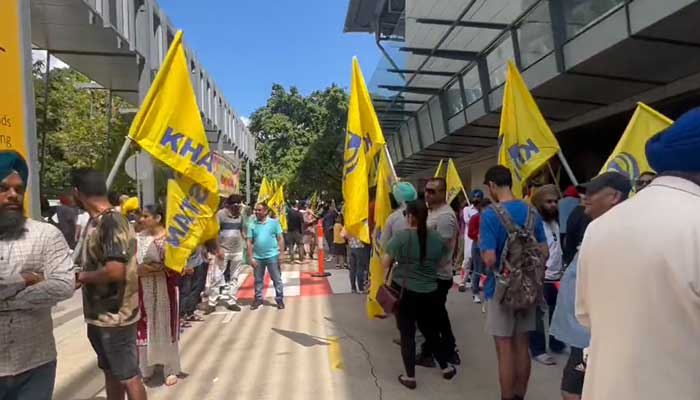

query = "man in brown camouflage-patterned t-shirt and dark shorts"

[71,168,146,400]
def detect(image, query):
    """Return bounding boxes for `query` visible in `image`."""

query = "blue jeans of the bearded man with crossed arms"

[0,360,56,400]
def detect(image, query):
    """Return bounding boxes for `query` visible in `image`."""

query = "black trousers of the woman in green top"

[392,283,449,378]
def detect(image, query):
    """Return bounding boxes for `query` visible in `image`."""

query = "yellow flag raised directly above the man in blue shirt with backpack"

[498,61,560,197]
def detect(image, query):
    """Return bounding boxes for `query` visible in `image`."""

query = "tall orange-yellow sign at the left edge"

[0,0,27,159]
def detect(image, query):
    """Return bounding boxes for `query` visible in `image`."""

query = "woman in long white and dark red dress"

[136,205,180,386]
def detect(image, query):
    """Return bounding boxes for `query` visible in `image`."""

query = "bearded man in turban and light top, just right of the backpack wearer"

[530,185,565,365]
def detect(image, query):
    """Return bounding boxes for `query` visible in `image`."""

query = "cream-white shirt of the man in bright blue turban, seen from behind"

[576,176,700,400]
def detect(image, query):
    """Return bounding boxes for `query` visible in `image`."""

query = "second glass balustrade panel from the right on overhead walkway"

[517,1,554,68]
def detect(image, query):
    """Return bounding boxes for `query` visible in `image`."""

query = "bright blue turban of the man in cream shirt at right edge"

[646,108,700,173]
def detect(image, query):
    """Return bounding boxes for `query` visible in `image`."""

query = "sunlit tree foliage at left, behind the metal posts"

[33,62,134,196]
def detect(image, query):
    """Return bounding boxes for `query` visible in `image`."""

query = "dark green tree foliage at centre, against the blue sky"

[249,84,348,199]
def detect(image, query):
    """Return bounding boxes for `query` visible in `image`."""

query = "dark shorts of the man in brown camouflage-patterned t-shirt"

[88,324,139,381]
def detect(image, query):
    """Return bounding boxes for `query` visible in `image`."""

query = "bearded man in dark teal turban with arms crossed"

[0,151,74,400]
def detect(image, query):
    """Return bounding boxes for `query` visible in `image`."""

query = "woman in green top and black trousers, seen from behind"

[382,200,457,389]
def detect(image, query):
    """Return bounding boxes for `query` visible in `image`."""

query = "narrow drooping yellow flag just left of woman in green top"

[367,151,394,318]
